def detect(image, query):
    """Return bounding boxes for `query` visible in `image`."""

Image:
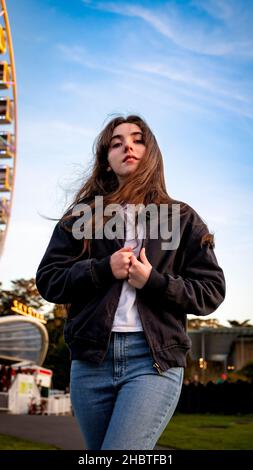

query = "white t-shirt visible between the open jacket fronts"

[112,204,143,332]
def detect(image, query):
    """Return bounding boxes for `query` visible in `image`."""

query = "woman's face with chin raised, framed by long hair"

[108,122,146,186]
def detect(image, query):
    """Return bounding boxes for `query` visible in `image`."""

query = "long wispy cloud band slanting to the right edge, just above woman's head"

[57,44,253,119]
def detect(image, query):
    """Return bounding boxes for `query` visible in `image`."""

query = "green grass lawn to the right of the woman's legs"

[158,413,253,450]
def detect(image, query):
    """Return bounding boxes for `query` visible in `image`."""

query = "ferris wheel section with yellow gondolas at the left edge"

[0,0,17,256]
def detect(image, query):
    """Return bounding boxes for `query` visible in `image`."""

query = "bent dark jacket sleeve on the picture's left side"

[36,222,114,304]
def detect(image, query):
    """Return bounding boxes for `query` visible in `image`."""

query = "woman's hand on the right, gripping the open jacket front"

[128,248,152,289]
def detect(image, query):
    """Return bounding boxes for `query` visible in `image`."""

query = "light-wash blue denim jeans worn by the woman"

[70,332,184,450]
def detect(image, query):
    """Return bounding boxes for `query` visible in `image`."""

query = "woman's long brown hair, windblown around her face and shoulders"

[61,115,172,241]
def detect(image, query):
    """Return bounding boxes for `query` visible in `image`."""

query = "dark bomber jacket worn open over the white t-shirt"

[36,201,225,372]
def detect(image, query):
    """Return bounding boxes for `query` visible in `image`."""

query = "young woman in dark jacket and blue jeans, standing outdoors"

[36,115,225,450]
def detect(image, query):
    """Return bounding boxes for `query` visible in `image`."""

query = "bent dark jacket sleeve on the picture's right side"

[141,224,226,315]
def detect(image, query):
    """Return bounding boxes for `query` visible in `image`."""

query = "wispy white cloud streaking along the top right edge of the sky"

[84,0,253,58]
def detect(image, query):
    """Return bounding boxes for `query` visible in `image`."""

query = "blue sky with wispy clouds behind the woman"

[0,0,253,324]
